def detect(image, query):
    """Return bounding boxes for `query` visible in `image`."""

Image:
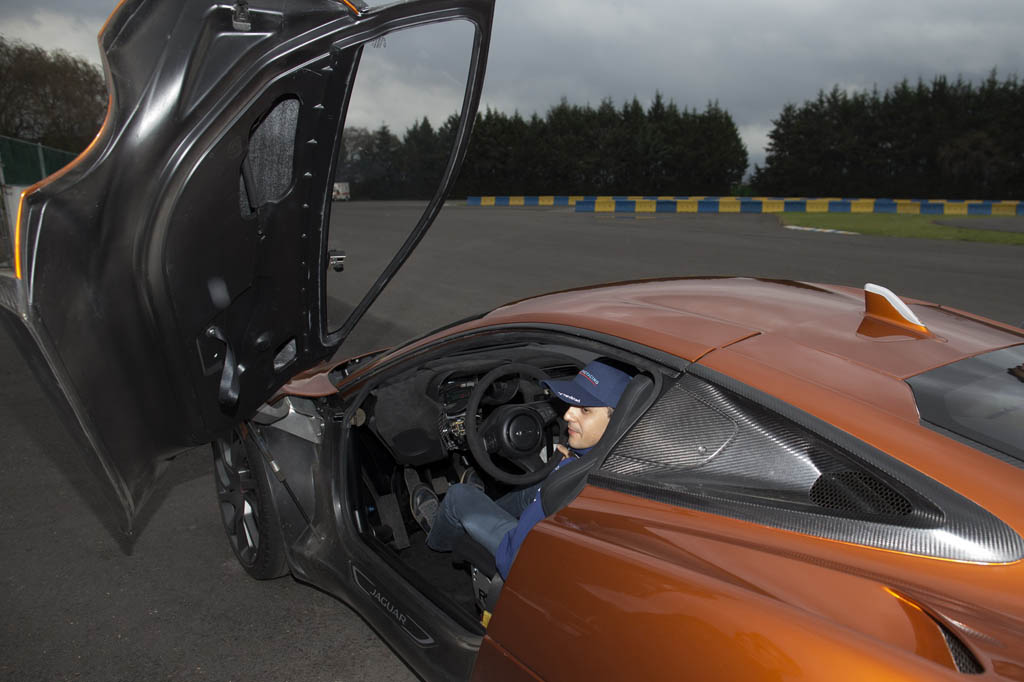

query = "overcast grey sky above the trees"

[0,0,1024,168]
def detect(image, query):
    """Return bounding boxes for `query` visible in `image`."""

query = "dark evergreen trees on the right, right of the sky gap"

[752,71,1024,199]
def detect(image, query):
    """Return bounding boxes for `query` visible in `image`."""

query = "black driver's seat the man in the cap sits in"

[453,374,660,628]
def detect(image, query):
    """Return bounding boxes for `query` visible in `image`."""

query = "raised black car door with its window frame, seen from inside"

[0,0,494,528]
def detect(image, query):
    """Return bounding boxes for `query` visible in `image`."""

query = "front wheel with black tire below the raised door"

[212,429,288,581]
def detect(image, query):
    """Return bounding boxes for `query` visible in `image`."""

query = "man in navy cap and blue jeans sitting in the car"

[410,361,630,579]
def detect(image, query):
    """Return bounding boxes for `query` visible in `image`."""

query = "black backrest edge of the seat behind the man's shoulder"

[541,374,654,516]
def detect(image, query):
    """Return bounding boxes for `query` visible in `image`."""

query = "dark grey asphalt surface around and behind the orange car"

[6,202,1024,682]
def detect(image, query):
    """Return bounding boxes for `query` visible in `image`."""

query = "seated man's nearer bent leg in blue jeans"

[427,483,518,554]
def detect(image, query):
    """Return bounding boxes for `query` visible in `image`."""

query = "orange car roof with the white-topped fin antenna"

[469,278,1024,421]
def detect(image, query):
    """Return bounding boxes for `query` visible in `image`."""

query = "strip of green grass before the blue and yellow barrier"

[777,213,1024,246]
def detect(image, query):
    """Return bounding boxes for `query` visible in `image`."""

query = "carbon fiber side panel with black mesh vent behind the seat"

[591,370,1024,563]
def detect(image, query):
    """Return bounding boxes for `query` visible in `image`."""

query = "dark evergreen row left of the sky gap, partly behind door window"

[337,93,746,199]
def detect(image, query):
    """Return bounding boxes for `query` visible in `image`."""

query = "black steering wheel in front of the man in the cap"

[466,363,561,485]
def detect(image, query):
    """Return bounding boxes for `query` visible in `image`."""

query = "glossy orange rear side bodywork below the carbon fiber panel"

[475,485,1024,680]
